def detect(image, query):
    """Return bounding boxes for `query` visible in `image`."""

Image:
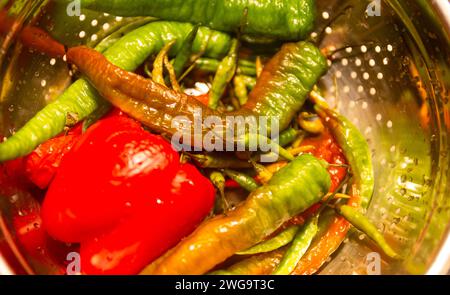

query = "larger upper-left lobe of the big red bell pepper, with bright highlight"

[42,117,179,243]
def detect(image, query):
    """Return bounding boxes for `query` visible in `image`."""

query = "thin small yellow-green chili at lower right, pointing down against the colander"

[336,205,400,259]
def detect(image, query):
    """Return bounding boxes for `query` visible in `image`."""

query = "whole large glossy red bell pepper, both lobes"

[42,116,214,274]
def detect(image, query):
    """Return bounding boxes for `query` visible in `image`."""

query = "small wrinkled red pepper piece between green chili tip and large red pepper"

[25,125,81,189]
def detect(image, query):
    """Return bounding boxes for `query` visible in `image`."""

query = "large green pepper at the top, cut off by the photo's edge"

[72,0,315,40]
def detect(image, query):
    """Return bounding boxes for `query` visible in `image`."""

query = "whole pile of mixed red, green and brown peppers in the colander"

[0,0,398,274]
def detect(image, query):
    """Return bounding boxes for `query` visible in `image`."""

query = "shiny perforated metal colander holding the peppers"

[0,0,450,274]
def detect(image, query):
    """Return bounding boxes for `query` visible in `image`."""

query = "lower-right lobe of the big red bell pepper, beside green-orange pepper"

[80,164,214,275]
